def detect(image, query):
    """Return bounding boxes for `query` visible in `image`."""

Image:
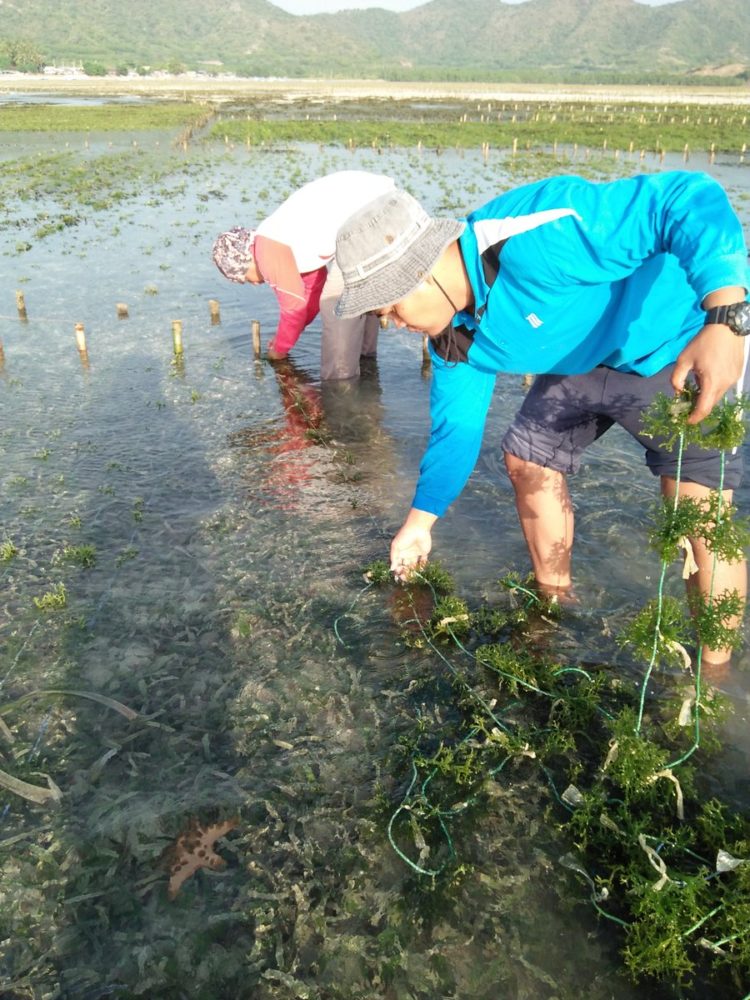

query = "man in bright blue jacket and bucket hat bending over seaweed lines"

[336,171,750,664]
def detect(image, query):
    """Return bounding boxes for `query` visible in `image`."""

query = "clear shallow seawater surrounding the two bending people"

[0,127,750,1000]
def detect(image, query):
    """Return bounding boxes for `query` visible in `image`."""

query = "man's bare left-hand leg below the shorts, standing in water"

[505,452,573,594]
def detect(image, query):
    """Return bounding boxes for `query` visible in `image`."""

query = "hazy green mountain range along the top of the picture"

[0,0,750,81]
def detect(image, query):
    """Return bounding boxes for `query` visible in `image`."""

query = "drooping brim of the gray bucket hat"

[335,219,466,319]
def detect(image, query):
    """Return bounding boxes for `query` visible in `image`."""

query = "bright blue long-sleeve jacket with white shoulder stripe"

[413,171,750,516]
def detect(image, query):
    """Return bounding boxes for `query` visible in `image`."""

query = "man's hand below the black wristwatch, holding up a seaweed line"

[672,323,745,424]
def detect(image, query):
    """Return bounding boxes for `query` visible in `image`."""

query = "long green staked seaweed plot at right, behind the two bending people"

[211,100,750,159]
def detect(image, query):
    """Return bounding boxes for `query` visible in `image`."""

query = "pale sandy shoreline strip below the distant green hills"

[0,73,750,105]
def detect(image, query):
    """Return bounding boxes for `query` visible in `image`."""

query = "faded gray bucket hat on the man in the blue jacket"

[336,188,466,317]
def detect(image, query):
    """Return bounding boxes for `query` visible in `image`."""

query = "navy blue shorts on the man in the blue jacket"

[502,365,747,489]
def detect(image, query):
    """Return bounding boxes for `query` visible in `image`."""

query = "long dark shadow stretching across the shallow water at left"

[0,357,263,1000]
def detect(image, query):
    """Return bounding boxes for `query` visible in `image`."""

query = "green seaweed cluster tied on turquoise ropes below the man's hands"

[368,390,750,996]
